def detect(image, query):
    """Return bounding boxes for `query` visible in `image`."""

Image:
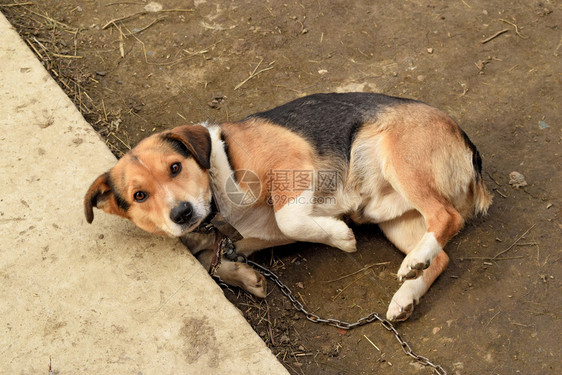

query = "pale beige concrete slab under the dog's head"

[0,14,287,374]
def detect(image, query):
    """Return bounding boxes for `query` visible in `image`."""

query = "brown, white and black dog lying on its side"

[84,93,491,320]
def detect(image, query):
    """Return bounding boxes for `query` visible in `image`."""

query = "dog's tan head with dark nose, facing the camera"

[84,125,211,237]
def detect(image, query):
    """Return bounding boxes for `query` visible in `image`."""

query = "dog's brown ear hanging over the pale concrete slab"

[84,172,128,224]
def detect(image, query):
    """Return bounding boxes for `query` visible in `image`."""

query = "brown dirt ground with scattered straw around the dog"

[0,0,562,375]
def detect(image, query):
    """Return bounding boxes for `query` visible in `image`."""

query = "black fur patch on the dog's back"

[246,92,415,160]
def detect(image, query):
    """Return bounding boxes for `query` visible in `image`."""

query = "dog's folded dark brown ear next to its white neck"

[164,125,211,169]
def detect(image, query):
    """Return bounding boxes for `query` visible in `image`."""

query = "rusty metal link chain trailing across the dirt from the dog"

[246,260,447,375]
